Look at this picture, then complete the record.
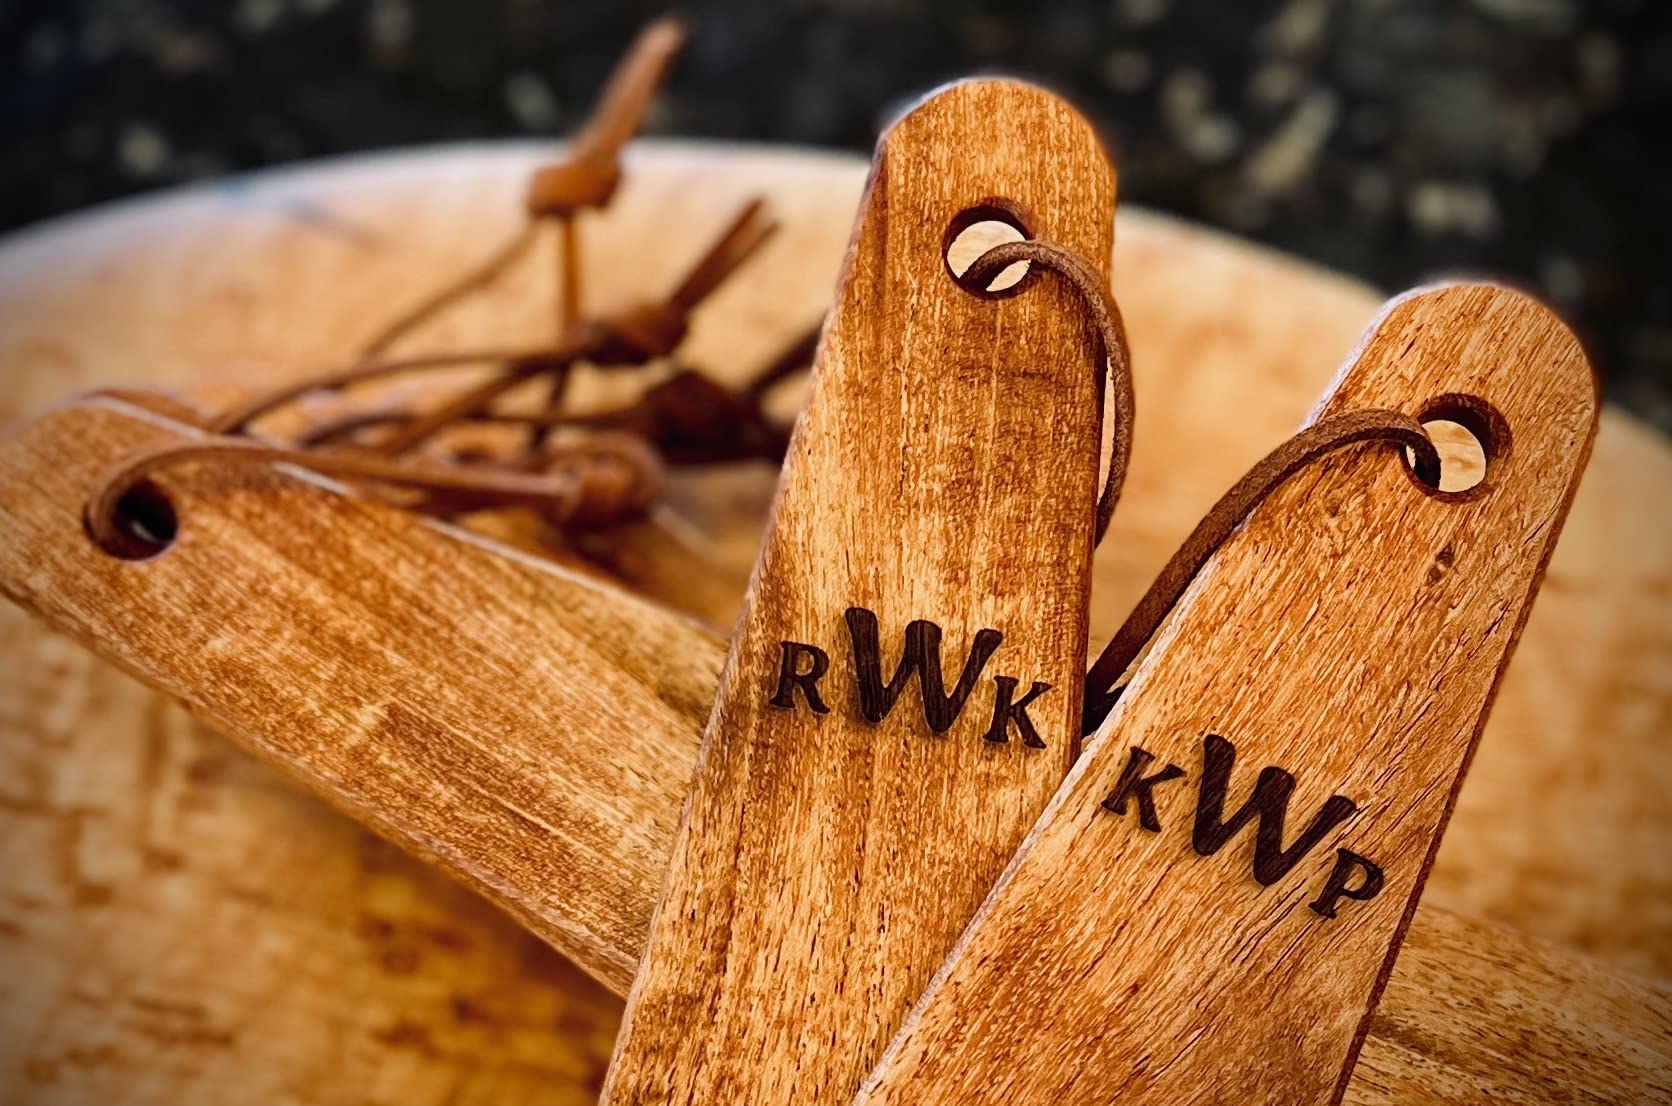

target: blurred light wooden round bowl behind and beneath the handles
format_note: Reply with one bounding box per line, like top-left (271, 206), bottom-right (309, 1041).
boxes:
top-left (0, 146), bottom-right (1672, 1104)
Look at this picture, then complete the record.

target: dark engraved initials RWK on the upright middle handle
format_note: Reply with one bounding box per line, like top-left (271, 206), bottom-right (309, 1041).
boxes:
top-left (767, 607), bottom-right (1050, 750)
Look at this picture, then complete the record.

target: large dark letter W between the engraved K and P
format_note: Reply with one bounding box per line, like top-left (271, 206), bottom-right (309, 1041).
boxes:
top-left (1190, 733), bottom-right (1358, 887)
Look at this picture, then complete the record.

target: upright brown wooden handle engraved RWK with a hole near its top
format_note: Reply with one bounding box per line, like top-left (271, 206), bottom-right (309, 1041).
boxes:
top-left (604, 80), bottom-right (1115, 1106)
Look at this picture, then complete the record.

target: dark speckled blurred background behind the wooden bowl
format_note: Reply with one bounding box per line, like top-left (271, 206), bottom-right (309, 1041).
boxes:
top-left (0, 0), bottom-right (1672, 430)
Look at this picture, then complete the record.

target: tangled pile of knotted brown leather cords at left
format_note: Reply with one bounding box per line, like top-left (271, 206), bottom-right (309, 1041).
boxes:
top-left (84, 17), bottom-right (794, 556)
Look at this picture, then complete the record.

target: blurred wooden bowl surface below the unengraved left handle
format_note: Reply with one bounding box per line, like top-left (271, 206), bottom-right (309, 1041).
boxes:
top-left (0, 604), bottom-right (620, 1106)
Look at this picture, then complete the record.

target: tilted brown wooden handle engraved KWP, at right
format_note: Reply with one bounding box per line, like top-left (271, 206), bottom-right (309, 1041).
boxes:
top-left (856, 284), bottom-right (1597, 1106)
